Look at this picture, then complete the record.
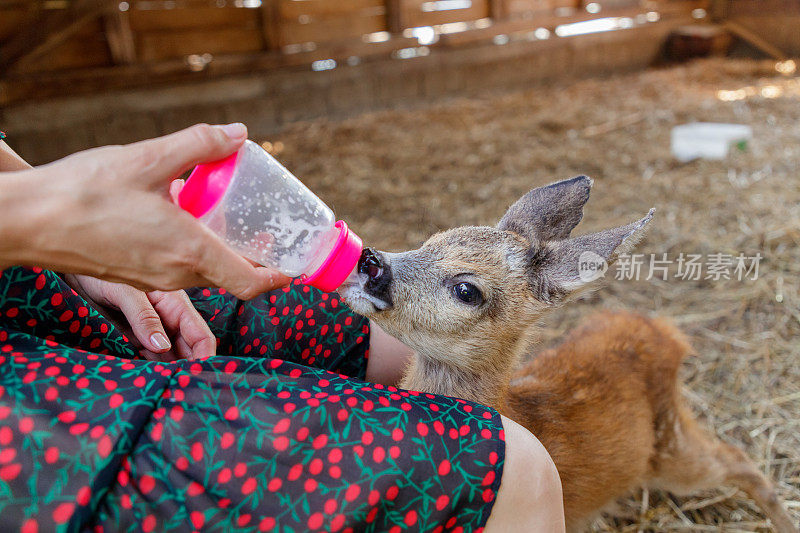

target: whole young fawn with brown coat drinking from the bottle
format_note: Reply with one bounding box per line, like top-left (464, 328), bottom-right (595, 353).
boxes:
top-left (340, 176), bottom-right (797, 533)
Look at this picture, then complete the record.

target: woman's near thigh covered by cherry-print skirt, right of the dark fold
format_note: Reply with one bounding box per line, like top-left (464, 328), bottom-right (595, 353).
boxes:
top-left (96, 357), bottom-right (504, 531)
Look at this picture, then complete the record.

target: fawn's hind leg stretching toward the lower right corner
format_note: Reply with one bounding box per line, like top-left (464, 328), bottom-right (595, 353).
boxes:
top-left (654, 406), bottom-right (798, 533)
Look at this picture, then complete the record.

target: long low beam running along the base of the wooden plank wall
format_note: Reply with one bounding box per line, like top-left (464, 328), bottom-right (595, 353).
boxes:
top-left (0, 15), bottom-right (692, 164)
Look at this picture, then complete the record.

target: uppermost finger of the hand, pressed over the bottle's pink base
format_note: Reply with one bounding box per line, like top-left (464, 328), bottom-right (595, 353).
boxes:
top-left (130, 122), bottom-right (247, 186)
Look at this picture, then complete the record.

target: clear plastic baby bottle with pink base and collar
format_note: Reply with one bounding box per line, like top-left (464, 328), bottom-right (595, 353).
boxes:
top-left (178, 140), bottom-right (362, 292)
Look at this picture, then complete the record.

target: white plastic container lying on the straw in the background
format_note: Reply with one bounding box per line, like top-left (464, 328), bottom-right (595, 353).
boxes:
top-left (671, 122), bottom-right (753, 162)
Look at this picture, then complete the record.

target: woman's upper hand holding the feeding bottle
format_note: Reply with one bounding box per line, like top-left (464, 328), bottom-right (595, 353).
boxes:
top-left (0, 124), bottom-right (289, 299)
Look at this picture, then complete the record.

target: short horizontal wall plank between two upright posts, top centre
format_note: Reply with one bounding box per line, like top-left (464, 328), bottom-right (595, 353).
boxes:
top-left (280, 14), bottom-right (387, 46)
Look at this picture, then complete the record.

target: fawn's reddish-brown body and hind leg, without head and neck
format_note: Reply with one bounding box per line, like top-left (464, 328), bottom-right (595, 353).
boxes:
top-left (504, 312), bottom-right (796, 533)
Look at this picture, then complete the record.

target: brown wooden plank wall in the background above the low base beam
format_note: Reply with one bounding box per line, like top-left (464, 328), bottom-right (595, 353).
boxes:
top-left (0, 0), bottom-right (692, 105)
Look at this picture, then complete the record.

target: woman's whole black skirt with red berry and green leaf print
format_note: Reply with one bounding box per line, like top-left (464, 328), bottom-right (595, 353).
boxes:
top-left (0, 267), bottom-right (505, 533)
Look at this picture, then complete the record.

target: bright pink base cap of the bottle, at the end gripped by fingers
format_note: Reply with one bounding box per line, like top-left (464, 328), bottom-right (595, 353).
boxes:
top-left (178, 152), bottom-right (239, 218)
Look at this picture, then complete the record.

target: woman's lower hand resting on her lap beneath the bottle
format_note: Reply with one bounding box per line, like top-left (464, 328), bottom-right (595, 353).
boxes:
top-left (65, 274), bottom-right (217, 361)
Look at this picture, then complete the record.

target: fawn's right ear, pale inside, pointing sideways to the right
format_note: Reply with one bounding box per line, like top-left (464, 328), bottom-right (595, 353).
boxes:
top-left (527, 209), bottom-right (655, 304)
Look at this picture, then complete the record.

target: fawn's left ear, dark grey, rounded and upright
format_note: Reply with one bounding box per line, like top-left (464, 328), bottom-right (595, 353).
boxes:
top-left (497, 176), bottom-right (592, 242)
